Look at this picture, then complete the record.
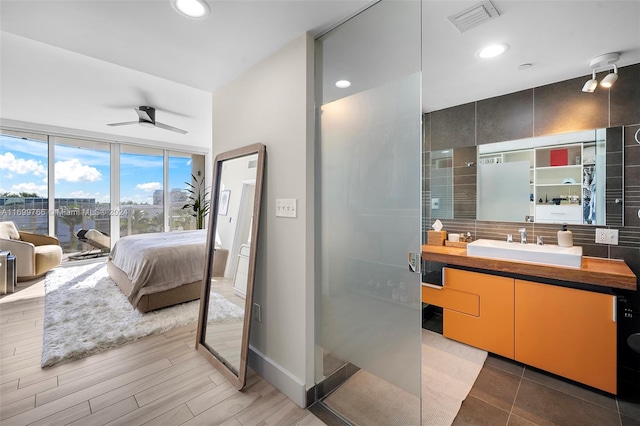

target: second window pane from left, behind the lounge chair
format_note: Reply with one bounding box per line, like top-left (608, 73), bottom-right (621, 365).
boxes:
top-left (54, 138), bottom-right (111, 253)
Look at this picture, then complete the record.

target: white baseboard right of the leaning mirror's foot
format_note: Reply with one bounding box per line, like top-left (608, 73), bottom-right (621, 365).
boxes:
top-left (249, 345), bottom-right (307, 408)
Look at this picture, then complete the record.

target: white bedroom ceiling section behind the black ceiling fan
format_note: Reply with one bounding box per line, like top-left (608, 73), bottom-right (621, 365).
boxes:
top-left (0, 31), bottom-right (212, 156)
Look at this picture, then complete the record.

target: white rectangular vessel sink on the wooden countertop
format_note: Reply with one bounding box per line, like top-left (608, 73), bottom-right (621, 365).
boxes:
top-left (467, 239), bottom-right (582, 268)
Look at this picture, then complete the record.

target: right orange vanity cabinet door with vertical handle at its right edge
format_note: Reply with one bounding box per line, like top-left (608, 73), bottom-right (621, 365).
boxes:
top-left (515, 279), bottom-right (617, 394)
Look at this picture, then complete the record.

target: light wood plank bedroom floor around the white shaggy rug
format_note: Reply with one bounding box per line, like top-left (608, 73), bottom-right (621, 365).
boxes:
top-left (0, 280), bottom-right (324, 426)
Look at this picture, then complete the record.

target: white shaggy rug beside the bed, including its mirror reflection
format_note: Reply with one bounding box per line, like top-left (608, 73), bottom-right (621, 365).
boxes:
top-left (41, 262), bottom-right (243, 367)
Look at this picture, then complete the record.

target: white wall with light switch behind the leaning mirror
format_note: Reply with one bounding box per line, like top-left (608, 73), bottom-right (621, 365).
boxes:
top-left (213, 34), bottom-right (314, 406)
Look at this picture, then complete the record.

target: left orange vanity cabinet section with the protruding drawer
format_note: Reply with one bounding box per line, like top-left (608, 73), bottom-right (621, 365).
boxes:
top-left (422, 268), bottom-right (514, 358)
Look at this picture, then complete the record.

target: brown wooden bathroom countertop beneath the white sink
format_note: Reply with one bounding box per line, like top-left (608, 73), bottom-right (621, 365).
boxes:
top-left (422, 244), bottom-right (637, 290)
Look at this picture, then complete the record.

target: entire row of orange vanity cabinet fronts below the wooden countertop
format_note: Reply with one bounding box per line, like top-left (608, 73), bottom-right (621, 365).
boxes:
top-left (422, 267), bottom-right (617, 394)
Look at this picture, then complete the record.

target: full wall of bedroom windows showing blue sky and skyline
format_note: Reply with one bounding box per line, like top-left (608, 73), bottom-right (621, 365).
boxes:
top-left (0, 129), bottom-right (205, 253)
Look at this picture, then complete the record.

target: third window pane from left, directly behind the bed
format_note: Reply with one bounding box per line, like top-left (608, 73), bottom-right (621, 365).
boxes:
top-left (120, 145), bottom-right (164, 237)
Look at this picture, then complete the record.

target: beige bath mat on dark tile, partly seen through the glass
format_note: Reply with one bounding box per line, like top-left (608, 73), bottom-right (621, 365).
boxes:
top-left (325, 330), bottom-right (487, 426)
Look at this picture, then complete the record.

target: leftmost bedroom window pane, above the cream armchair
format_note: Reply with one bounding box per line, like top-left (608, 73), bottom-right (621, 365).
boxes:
top-left (0, 131), bottom-right (49, 234)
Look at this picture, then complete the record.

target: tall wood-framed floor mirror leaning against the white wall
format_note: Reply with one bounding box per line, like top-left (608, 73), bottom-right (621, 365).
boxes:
top-left (196, 144), bottom-right (266, 389)
